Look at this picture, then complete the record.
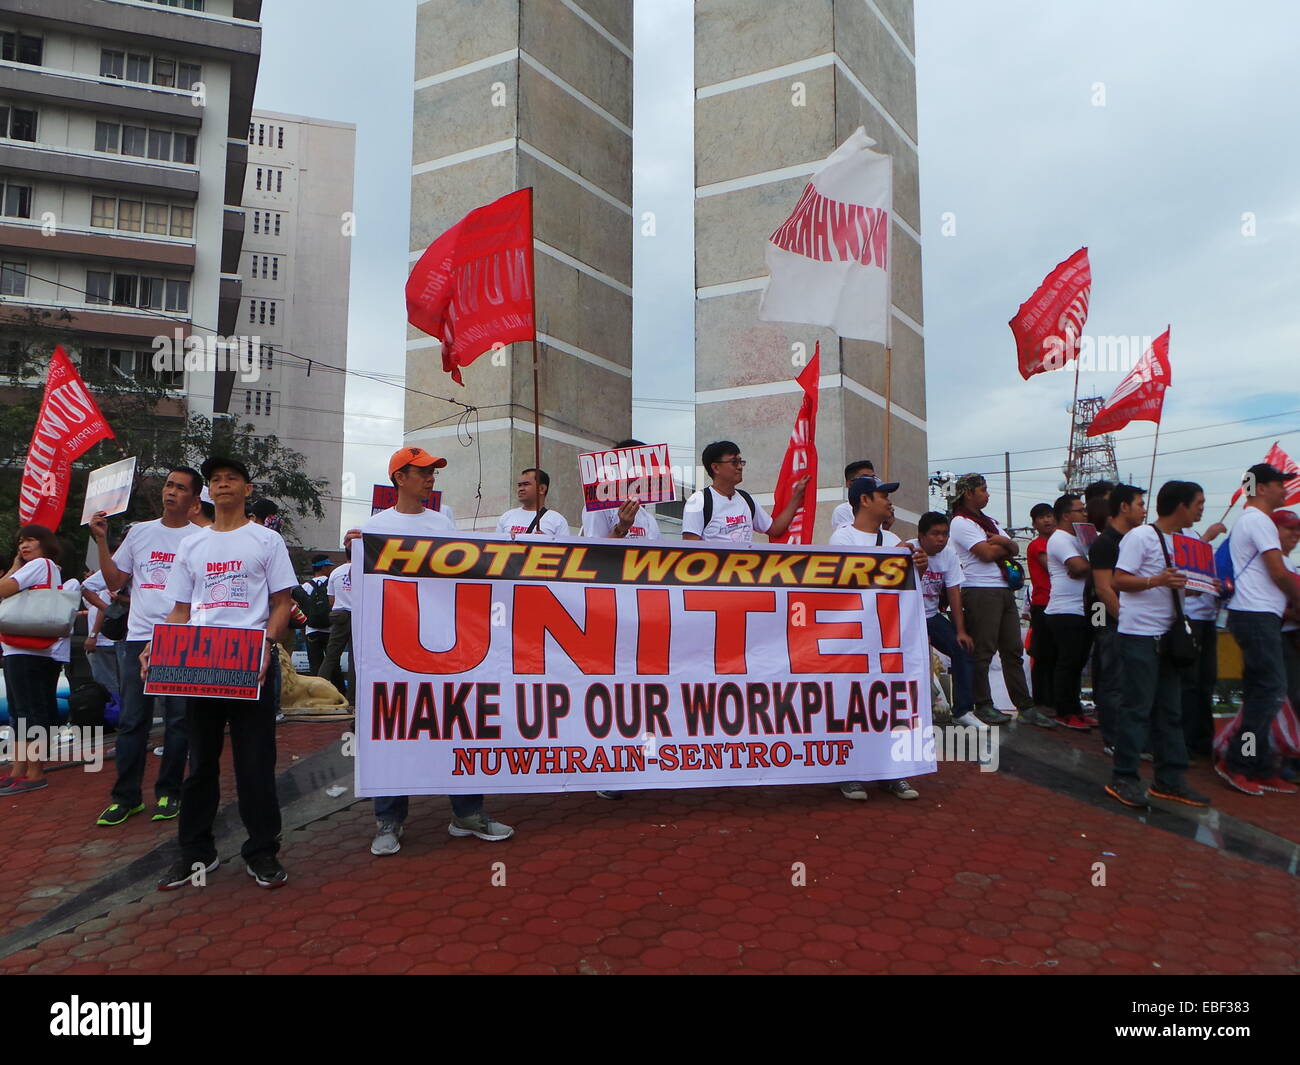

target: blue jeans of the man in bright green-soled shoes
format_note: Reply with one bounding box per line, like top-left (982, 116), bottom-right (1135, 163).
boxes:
top-left (111, 640), bottom-right (190, 809)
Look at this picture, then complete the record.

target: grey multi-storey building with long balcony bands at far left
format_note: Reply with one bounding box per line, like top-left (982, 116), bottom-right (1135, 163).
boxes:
top-left (0, 0), bottom-right (261, 414)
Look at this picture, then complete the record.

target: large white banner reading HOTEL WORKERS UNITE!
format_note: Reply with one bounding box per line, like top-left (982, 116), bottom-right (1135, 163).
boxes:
top-left (352, 533), bottom-right (935, 796)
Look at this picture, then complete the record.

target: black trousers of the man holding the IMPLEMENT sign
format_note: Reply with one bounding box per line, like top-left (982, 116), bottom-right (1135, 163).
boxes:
top-left (178, 649), bottom-right (280, 863)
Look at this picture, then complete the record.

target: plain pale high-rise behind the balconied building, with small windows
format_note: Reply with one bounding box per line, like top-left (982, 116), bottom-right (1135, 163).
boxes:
top-left (239, 111), bottom-right (356, 550)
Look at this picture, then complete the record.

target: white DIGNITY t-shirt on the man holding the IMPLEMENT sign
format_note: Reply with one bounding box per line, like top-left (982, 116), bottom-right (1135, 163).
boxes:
top-left (166, 521), bottom-right (298, 628)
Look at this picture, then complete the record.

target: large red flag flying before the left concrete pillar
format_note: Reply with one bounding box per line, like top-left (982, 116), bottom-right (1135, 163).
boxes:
top-left (406, 189), bottom-right (537, 385)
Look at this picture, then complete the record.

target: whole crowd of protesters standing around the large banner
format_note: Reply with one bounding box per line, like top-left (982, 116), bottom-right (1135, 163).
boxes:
top-left (0, 440), bottom-right (1300, 889)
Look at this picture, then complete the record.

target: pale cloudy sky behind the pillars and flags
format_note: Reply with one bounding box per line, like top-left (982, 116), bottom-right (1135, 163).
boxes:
top-left (256, 0), bottom-right (1300, 538)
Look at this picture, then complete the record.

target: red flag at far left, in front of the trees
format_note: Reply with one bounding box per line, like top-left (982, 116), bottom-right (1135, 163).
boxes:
top-left (18, 347), bottom-right (113, 531)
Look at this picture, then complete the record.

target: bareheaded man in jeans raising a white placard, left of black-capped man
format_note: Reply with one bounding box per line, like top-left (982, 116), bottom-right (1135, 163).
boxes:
top-left (90, 466), bottom-right (203, 828)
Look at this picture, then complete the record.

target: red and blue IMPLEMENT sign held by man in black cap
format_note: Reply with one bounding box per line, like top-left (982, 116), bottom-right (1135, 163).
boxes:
top-left (144, 624), bottom-right (267, 700)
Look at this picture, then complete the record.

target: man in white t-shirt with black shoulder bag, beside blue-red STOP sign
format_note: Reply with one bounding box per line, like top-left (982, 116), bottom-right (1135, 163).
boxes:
top-left (1106, 481), bottom-right (1210, 808)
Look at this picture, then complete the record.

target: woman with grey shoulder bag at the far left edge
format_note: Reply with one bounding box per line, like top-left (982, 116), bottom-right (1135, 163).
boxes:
top-left (0, 525), bottom-right (69, 796)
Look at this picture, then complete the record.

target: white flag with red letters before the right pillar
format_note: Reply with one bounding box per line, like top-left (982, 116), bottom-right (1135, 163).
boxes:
top-left (758, 126), bottom-right (893, 343)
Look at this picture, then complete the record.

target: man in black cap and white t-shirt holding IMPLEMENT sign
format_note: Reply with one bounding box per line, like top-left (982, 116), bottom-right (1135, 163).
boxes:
top-left (150, 458), bottom-right (298, 891)
